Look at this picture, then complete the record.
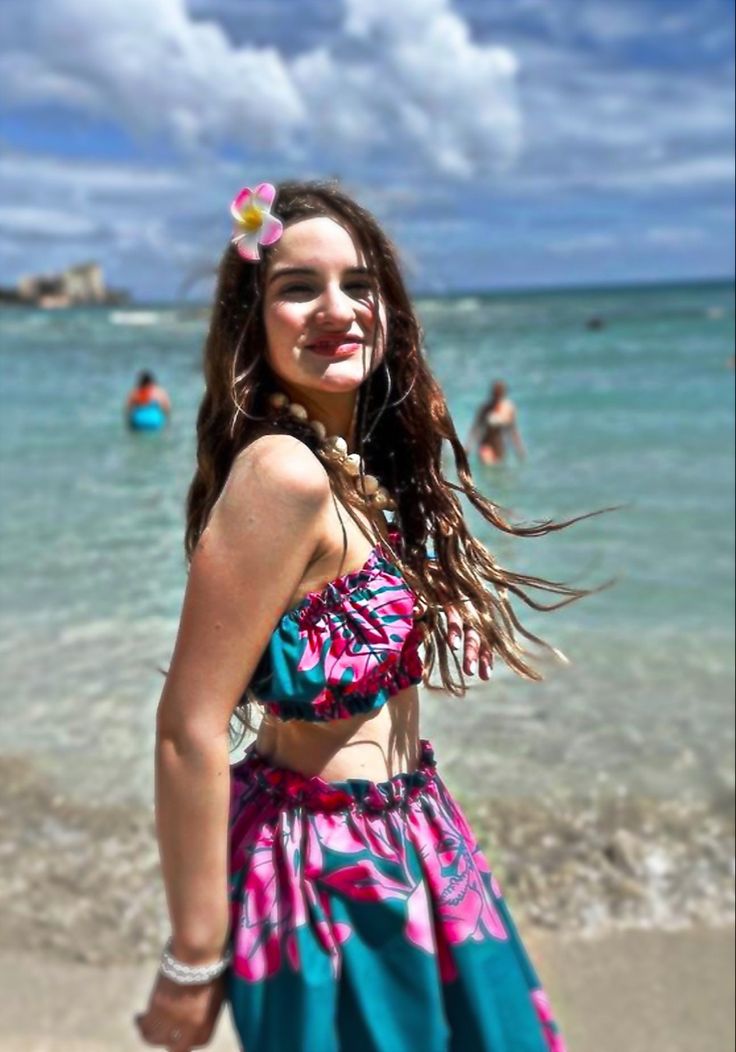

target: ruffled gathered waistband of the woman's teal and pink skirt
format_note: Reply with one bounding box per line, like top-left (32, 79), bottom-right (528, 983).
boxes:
top-left (232, 739), bottom-right (437, 812)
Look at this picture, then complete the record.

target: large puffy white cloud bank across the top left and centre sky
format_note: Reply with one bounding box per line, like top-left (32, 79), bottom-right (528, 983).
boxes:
top-left (0, 0), bottom-right (520, 176)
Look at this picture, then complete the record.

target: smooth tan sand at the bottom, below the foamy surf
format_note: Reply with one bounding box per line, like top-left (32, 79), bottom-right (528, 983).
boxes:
top-left (0, 928), bottom-right (734, 1052)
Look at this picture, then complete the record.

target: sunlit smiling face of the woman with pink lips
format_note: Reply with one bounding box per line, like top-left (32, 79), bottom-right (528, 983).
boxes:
top-left (263, 216), bottom-right (386, 404)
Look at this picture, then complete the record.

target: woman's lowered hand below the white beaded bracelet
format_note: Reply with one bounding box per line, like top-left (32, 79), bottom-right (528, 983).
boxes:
top-left (135, 974), bottom-right (225, 1052)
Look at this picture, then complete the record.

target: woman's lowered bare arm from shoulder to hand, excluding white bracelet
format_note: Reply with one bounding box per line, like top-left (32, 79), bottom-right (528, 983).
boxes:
top-left (139, 436), bottom-right (331, 1044)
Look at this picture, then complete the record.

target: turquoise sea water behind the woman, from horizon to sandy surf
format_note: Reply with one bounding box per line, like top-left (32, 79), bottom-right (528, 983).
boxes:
top-left (0, 285), bottom-right (734, 801)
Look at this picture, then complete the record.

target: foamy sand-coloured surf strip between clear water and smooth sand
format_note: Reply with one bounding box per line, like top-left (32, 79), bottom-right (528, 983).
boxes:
top-left (0, 757), bottom-right (734, 968)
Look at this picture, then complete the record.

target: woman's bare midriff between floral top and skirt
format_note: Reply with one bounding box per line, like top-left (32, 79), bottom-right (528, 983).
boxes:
top-left (255, 687), bottom-right (420, 782)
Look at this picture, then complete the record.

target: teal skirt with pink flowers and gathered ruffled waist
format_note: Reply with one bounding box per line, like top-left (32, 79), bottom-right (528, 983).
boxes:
top-left (228, 741), bottom-right (565, 1052)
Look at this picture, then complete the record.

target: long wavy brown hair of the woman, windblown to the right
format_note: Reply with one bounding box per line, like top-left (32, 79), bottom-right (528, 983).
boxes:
top-left (185, 182), bottom-right (600, 726)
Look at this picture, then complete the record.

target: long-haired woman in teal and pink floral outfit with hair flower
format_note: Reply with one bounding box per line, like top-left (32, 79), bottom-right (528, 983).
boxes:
top-left (132, 182), bottom-right (597, 1052)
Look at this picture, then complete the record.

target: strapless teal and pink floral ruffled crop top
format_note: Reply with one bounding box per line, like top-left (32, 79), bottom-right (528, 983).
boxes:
top-left (248, 532), bottom-right (423, 722)
